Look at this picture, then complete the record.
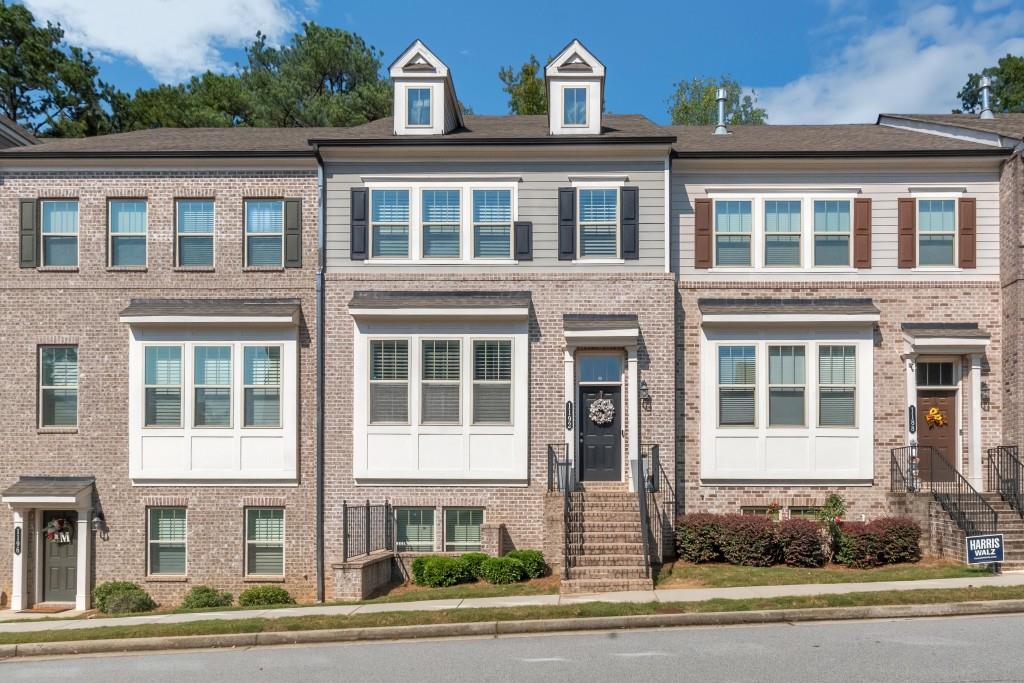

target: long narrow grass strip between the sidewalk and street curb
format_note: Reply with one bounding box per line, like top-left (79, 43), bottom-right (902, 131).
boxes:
top-left (0, 586), bottom-right (1024, 644)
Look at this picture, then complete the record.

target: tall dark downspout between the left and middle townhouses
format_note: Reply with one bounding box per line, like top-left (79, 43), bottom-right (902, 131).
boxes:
top-left (313, 145), bottom-right (327, 602)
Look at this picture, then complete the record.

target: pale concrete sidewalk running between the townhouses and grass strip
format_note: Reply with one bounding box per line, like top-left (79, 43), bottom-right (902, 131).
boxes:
top-left (0, 572), bottom-right (1024, 633)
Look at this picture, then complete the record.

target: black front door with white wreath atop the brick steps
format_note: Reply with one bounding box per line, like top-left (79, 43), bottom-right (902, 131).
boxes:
top-left (579, 386), bottom-right (623, 481)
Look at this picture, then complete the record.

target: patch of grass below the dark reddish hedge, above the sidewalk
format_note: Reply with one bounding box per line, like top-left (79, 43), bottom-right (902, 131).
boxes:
top-left (657, 560), bottom-right (988, 588)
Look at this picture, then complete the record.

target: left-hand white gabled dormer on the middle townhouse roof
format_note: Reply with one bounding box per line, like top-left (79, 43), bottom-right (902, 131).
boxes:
top-left (388, 40), bottom-right (462, 135)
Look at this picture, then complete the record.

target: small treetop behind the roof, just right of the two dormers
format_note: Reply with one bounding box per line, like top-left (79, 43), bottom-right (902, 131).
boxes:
top-left (669, 76), bottom-right (768, 126)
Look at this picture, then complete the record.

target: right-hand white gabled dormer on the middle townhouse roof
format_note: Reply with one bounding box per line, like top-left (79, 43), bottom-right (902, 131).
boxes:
top-left (544, 39), bottom-right (604, 135)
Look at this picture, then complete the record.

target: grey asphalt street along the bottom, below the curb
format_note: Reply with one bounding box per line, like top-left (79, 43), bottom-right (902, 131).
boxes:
top-left (0, 615), bottom-right (1024, 683)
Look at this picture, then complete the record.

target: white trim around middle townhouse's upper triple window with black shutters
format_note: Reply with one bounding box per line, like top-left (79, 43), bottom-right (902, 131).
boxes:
top-left (361, 177), bottom-right (519, 266)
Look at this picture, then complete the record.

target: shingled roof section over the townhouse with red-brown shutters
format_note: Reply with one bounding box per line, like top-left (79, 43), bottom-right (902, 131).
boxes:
top-left (667, 124), bottom-right (1007, 158)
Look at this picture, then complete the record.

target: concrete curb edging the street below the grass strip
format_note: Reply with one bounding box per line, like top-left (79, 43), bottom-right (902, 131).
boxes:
top-left (6, 600), bottom-right (1024, 659)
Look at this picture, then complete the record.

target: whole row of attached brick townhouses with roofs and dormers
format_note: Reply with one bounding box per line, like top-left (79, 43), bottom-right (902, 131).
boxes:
top-left (0, 41), bottom-right (1024, 609)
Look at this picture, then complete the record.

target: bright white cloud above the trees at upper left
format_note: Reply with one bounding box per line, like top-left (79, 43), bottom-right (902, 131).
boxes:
top-left (25, 0), bottom-right (297, 83)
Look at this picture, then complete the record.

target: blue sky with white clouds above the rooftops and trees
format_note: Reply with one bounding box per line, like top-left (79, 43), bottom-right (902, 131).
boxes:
top-left (24, 0), bottom-right (1024, 123)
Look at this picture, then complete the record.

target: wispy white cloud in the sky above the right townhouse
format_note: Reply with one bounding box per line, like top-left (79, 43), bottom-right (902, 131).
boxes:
top-left (755, 5), bottom-right (1024, 124)
